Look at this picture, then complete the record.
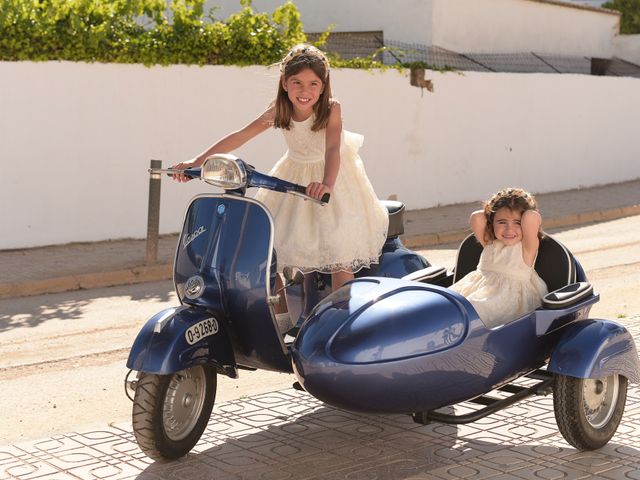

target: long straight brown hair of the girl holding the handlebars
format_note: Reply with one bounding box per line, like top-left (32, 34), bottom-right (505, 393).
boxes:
top-left (273, 44), bottom-right (331, 132)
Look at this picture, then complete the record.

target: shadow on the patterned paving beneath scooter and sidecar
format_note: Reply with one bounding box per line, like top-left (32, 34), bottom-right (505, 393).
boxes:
top-left (136, 400), bottom-right (640, 480)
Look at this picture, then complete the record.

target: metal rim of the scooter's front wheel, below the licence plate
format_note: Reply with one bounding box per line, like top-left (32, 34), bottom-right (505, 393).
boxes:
top-left (162, 366), bottom-right (207, 441)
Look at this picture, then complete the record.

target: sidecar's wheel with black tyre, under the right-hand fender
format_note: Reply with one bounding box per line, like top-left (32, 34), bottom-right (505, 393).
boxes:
top-left (553, 374), bottom-right (627, 450)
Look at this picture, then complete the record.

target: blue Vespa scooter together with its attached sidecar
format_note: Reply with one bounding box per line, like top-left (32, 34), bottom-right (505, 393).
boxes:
top-left (127, 155), bottom-right (640, 459)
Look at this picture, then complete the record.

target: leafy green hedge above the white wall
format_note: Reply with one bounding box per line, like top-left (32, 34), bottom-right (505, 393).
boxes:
top-left (0, 0), bottom-right (306, 65)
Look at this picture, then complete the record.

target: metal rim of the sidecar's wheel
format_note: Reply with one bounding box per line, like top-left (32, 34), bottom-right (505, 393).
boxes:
top-left (582, 375), bottom-right (620, 429)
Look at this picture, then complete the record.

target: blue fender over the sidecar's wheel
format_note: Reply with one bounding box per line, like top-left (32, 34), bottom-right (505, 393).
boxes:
top-left (547, 320), bottom-right (640, 383)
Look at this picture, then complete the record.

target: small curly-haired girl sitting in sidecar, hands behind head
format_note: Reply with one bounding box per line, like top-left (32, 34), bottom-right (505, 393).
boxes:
top-left (451, 188), bottom-right (547, 328)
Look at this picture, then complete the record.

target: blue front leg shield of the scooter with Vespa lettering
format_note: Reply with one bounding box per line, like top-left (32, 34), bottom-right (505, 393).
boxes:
top-left (174, 195), bottom-right (291, 372)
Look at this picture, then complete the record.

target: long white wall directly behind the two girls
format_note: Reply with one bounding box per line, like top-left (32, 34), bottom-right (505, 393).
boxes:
top-left (0, 62), bottom-right (640, 249)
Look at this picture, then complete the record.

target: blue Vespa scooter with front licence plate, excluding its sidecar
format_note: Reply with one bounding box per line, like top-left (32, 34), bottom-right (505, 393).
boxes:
top-left (126, 154), bottom-right (436, 459)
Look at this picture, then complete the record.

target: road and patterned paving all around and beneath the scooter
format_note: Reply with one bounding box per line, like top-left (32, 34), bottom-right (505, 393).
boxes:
top-left (0, 216), bottom-right (640, 479)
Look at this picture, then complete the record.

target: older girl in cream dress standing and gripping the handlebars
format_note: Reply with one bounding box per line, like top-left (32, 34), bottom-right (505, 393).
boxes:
top-left (172, 45), bottom-right (388, 289)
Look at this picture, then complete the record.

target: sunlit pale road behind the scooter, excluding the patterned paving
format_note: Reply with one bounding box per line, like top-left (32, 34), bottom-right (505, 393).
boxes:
top-left (0, 216), bottom-right (640, 443)
